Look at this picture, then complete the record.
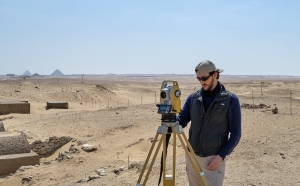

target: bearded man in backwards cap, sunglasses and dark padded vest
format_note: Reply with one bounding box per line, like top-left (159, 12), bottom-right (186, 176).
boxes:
top-left (177, 60), bottom-right (241, 186)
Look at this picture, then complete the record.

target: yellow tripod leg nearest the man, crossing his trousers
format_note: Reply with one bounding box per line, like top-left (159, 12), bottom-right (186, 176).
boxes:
top-left (177, 132), bottom-right (210, 186)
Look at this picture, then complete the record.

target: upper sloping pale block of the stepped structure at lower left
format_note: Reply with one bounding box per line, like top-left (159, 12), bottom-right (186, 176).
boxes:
top-left (0, 135), bottom-right (31, 155)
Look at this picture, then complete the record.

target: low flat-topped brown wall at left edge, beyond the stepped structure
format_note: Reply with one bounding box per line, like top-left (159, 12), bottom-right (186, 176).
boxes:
top-left (0, 102), bottom-right (30, 115)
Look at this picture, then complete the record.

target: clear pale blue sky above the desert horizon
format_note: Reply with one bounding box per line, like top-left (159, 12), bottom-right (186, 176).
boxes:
top-left (0, 0), bottom-right (300, 76)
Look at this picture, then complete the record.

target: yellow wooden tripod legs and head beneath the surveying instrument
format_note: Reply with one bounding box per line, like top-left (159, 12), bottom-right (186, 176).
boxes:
top-left (136, 120), bottom-right (210, 186)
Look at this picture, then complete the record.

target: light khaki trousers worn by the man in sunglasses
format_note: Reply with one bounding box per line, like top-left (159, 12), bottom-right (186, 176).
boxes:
top-left (185, 155), bottom-right (225, 186)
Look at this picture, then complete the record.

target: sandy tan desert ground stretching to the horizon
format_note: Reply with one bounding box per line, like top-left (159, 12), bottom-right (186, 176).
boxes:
top-left (0, 74), bottom-right (300, 186)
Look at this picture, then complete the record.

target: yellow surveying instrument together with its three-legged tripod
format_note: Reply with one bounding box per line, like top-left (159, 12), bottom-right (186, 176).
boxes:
top-left (136, 80), bottom-right (210, 186)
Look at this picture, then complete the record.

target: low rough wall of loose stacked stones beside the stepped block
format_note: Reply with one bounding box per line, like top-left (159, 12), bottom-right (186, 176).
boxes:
top-left (29, 136), bottom-right (72, 155)
